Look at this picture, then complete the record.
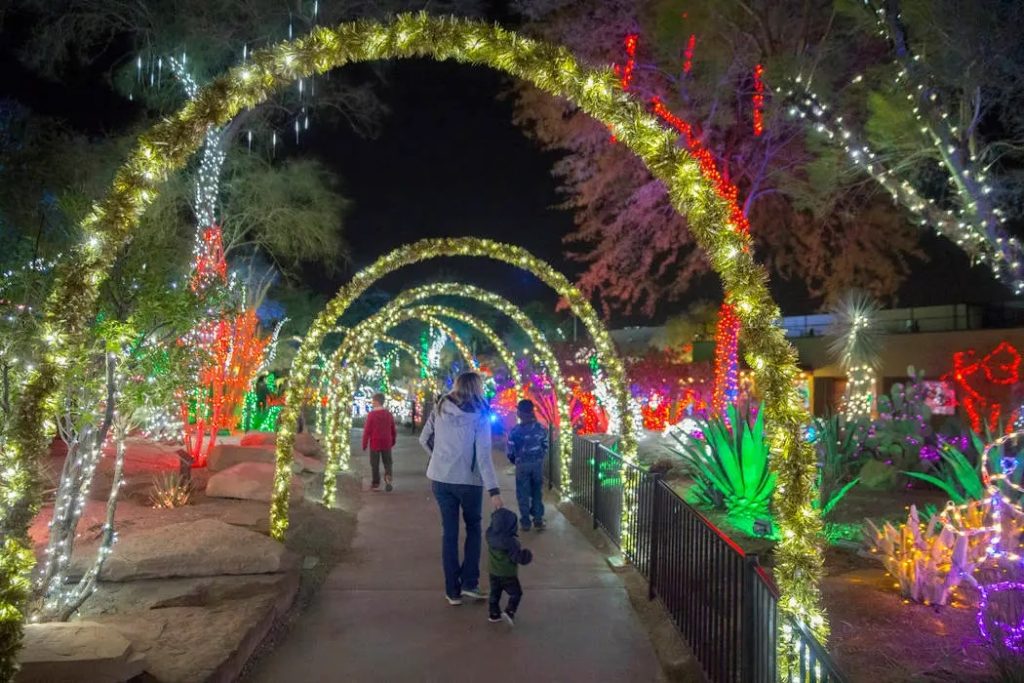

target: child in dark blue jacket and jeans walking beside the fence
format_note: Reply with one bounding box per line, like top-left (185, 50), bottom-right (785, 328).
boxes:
top-left (508, 399), bottom-right (548, 531)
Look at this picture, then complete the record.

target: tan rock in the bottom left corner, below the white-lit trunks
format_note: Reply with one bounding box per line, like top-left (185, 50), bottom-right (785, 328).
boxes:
top-left (14, 622), bottom-right (145, 683)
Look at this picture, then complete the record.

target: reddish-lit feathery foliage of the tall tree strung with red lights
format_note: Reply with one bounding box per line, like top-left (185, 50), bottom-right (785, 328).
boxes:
top-left (517, 0), bottom-right (918, 313)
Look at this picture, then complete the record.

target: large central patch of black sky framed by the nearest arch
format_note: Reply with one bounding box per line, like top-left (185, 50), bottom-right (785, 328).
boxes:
top-left (302, 59), bottom-right (578, 311)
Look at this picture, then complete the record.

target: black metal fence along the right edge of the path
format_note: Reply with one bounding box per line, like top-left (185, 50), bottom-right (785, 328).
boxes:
top-left (561, 436), bottom-right (845, 683)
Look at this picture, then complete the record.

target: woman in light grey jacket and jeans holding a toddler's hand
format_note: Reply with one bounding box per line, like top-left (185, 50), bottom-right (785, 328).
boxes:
top-left (420, 373), bottom-right (502, 605)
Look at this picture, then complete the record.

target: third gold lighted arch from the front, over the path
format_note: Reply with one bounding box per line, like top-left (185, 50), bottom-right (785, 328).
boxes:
top-left (307, 283), bottom-right (572, 505)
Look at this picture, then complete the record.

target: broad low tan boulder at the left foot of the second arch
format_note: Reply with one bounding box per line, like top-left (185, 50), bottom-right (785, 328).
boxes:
top-left (100, 519), bottom-right (294, 581)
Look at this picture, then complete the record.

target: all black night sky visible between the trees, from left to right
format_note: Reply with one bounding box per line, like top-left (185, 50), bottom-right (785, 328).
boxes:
top-left (0, 16), bottom-right (1008, 325)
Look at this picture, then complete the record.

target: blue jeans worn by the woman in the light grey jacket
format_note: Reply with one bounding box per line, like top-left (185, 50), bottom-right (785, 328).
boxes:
top-left (430, 481), bottom-right (483, 598)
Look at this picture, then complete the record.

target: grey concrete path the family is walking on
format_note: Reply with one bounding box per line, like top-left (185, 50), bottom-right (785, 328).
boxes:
top-left (252, 436), bottom-right (659, 683)
